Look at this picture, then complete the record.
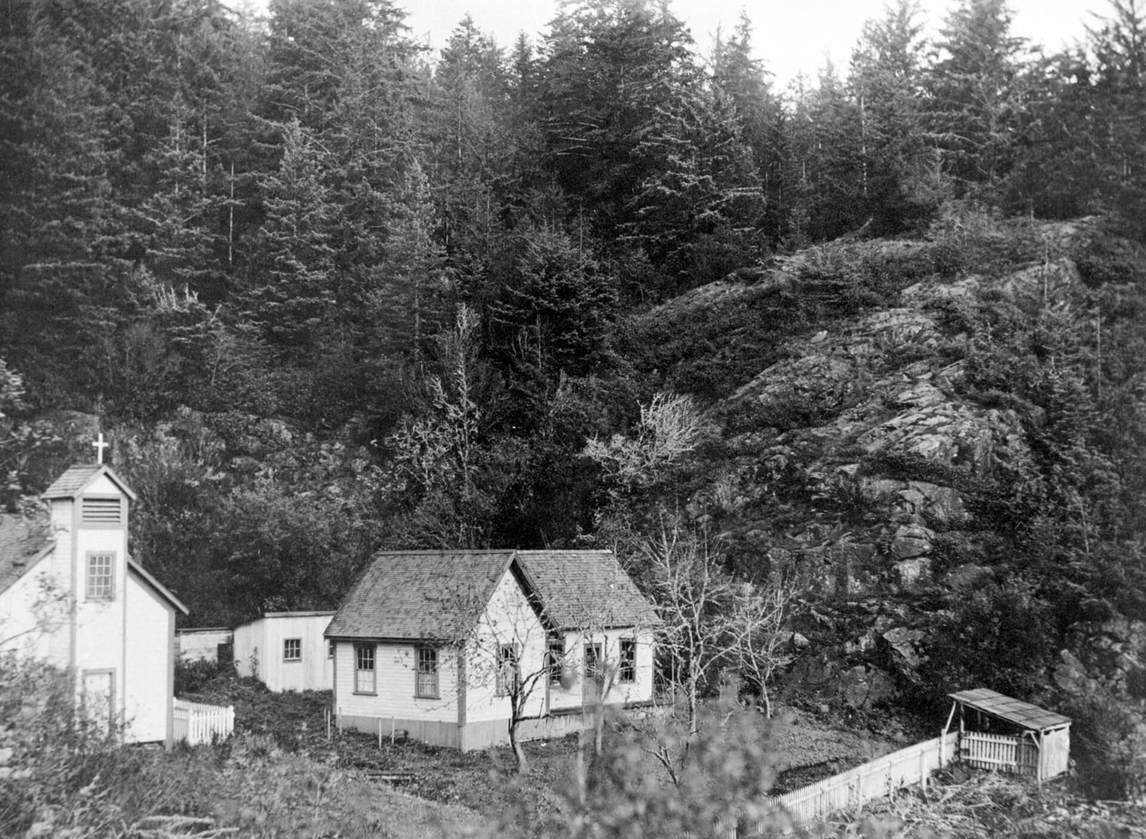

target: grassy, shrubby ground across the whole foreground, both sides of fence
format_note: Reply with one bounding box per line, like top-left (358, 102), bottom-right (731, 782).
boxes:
top-left (8, 660), bottom-right (1146, 839)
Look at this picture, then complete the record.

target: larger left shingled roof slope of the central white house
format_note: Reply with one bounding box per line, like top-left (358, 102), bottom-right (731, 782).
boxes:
top-left (325, 550), bottom-right (513, 641)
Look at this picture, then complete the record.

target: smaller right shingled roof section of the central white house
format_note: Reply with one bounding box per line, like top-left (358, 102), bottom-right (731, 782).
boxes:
top-left (516, 550), bottom-right (661, 629)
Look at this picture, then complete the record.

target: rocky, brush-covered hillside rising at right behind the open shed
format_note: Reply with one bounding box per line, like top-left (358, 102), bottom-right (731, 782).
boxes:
top-left (631, 213), bottom-right (1146, 793)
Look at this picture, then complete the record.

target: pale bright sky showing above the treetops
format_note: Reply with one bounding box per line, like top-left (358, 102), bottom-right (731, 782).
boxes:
top-left (398, 0), bottom-right (1109, 85)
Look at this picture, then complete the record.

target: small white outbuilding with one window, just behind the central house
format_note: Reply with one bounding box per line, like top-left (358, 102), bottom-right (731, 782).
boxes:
top-left (234, 612), bottom-right (335, 691)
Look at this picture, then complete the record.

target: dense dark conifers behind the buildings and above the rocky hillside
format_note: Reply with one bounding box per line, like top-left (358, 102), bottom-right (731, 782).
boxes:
top-left (0, 0), bottom-right (1146, 641)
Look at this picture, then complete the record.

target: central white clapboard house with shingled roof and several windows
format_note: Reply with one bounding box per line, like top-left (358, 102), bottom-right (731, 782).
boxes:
top-left (327, 550), bottom-right (659, 750)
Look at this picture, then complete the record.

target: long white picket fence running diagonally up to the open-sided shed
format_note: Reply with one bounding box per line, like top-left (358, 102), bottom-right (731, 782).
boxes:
top-left (774, 731), bottom-right (959, 824)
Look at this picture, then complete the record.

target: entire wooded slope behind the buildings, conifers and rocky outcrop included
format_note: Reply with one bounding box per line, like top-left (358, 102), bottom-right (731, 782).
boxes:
top-left (0, 0), bottom-right (1146, 798)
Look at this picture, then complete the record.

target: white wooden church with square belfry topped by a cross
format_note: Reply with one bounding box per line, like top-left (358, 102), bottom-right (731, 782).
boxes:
top-left (0, 458), bottom-right (187, 744)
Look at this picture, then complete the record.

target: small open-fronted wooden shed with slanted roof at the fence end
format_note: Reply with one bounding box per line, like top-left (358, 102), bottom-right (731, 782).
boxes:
top-left (943, 688), bottom-right (1070, 781)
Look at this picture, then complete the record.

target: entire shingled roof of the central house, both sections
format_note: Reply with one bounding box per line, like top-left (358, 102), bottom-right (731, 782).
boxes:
top-left (325, 550), bottom-right (659, 641)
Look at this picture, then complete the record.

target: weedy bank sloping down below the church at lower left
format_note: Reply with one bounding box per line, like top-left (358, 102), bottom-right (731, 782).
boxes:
top-left (0, 658), bottom-right (476, 839)
